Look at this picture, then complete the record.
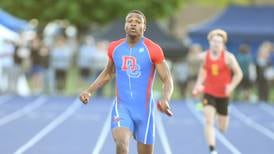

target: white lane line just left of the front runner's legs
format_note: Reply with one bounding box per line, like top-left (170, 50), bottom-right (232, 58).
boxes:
top-left (92, 101), bottom-right (113, 154)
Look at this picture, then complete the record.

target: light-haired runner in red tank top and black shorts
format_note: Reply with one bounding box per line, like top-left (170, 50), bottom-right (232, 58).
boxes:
top-left (193, 29), bottom-right (243, 154)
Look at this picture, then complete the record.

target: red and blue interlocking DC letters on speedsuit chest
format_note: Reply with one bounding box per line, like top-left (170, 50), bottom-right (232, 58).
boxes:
top-left (122, 56), bottom-right (141, 78)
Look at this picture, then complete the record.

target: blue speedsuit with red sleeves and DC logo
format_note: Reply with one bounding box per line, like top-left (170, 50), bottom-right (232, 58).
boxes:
top-left (108, 37), bottom-right (164, 144)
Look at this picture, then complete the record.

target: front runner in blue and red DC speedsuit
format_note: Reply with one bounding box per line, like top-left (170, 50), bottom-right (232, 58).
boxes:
top-left (80, 10), bottom-right (173, 154)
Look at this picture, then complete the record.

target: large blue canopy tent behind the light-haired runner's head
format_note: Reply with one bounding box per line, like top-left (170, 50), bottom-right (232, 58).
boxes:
top-left (188, 6), bottom-right (274, 56)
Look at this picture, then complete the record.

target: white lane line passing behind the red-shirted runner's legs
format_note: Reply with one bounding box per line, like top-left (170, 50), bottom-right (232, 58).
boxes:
top-left (186, 101), bottom-right (241, 154)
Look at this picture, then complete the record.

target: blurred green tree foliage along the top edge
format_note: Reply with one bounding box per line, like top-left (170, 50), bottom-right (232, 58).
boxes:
top-left (0, 0), bottom-right (184, 27)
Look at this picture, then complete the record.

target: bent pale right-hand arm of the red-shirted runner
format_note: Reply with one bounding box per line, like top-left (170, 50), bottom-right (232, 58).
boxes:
top-left (226, 53), bottom-right (243, 96)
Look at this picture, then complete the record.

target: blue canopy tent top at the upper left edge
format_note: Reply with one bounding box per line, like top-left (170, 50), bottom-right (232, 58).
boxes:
top-left (0, 9), bottom-right (28, 32)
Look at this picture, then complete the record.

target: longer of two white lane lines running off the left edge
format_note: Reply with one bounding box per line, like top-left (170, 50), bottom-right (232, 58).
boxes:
top-left (0, 96), bottom-right (46, 126)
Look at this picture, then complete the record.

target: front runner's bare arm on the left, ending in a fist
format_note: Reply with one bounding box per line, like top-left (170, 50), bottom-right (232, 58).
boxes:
top-left (80, 60), bottom-right (115, 104)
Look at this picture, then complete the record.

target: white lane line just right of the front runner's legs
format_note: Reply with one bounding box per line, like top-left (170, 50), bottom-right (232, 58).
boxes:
top-left (156, 114), bottom-right (172, 154)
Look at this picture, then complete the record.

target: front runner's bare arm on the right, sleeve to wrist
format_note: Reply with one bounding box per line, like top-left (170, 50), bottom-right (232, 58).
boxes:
top-left (156, 60), bottom-right (173, 108)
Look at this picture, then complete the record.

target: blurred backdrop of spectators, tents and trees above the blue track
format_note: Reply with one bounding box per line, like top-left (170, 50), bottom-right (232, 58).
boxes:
top-left (0, 0), bottom-right (274, 102)
